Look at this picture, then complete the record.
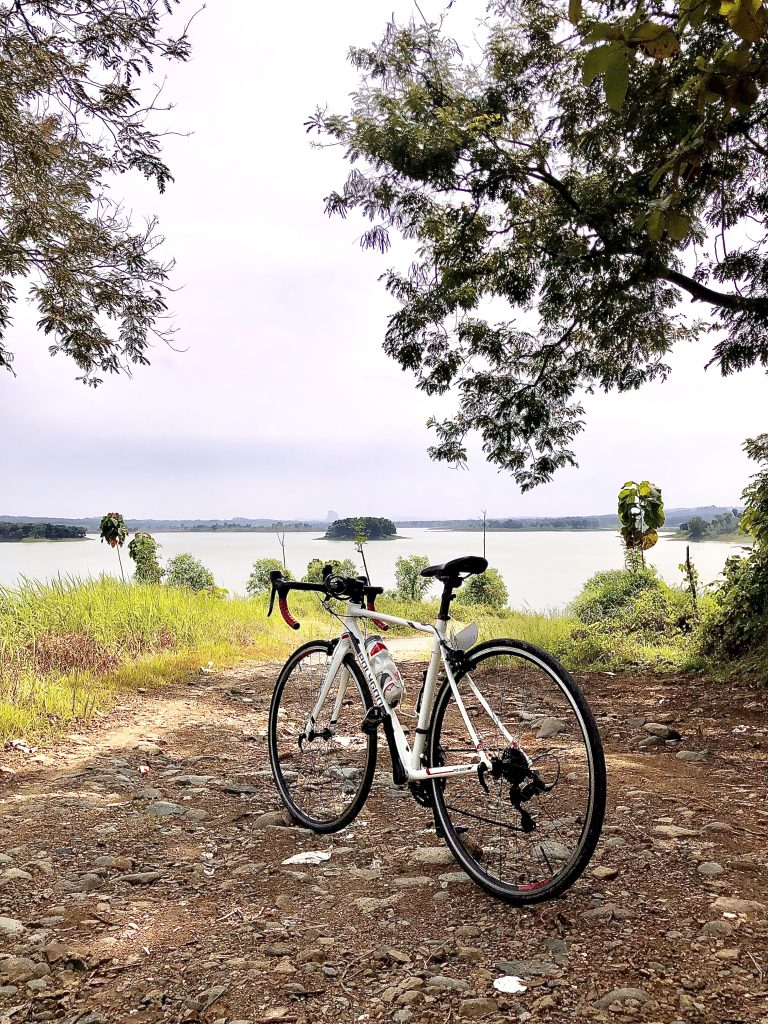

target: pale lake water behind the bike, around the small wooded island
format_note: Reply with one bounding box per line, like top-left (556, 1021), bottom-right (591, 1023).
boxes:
top-left (0, 527), bottom-right (741, 610)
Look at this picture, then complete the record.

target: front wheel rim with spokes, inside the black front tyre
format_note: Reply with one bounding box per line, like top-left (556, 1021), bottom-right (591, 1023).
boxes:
top-left (270, 646), bottom-right (370, 824)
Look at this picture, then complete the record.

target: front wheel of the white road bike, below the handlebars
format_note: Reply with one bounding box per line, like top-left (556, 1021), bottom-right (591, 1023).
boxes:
top-left (267, 640), bottom-right (376, 833)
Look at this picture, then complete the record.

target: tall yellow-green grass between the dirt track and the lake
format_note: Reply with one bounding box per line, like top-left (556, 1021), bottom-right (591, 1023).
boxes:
top-left (0, 577), bottom-right (692, 738)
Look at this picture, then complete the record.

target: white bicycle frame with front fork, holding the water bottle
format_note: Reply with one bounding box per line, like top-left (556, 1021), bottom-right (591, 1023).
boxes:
top-left (304, 603), bottom-right (518, 784)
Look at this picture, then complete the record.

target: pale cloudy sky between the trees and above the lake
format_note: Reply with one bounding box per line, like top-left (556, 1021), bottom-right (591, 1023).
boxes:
top-left (0, 0), bottom-right (766, 517)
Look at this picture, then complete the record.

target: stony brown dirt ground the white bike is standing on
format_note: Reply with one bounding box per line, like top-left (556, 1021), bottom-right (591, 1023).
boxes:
top-left (0, 664), bottom-right (768, 1024)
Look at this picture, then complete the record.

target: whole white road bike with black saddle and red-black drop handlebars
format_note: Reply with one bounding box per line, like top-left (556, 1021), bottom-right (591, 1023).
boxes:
top-left (268, 556), bottom-right (605, 905)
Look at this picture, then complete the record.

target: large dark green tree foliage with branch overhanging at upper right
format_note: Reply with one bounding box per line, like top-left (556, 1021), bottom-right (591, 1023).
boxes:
top-left (308, 8), bottom-right (768, 489)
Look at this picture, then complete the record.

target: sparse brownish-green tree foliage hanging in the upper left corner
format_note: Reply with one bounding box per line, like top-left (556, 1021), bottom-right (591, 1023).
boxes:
top-left (0, 0), bottom-right (189, 384)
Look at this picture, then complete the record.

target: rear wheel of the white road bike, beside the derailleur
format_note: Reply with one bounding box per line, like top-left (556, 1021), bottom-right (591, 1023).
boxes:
top-left (429, 640), bottom-right (605, 905)
